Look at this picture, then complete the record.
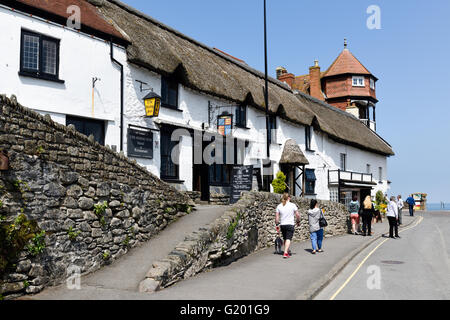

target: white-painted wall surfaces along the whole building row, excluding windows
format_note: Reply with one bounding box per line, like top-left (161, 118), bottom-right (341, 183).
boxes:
top-left (0, 7), bottom-right (388, 199)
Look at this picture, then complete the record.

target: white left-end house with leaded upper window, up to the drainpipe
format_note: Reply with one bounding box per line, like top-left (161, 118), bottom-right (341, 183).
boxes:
top-left (0, 1), bottom-right (126, 147)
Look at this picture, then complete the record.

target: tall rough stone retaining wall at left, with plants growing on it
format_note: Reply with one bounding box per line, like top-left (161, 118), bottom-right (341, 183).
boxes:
top-left (0, 96), bottom-right (193, 298)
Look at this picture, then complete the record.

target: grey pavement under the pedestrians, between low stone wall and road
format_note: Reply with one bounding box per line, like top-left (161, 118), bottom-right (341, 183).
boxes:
top-left (145, 217), bottom-right (413, 300)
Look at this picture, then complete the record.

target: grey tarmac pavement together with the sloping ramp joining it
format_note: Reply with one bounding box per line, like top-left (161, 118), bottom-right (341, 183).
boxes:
top-left (24, 206), bottom-right (416, 300)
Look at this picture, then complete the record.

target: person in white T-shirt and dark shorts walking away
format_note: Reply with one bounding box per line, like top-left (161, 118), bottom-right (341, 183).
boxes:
top-left (275, 193), bottom-right (300, 259)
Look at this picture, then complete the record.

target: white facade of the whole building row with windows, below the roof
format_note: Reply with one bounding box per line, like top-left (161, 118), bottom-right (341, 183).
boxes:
top-left (0, 1), bottom-right (393, 203)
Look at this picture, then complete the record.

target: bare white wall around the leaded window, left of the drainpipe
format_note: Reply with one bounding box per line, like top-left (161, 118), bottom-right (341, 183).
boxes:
top-left (0, 7), bottom-right (126, 148)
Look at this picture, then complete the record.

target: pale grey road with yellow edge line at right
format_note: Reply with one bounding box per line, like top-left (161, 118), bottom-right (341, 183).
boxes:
top-left (316, 212), bottom-right (450, 300)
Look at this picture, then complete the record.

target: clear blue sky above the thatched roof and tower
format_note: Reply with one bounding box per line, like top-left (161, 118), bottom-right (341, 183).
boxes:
top-left (125, 0), bottom-right (450, 202)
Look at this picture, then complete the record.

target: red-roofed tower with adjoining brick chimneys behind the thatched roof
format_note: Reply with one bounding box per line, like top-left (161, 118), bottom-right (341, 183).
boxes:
top-left (277, 39), bottom-right (378, 130)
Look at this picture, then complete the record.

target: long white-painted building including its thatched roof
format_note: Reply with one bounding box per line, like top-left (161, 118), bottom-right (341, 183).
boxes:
top-left (0, 0), bottom-right (393, 202)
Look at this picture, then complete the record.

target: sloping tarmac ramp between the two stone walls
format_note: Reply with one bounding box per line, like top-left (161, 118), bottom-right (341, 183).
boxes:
top-left (30, 205), bottom-right (226, 300)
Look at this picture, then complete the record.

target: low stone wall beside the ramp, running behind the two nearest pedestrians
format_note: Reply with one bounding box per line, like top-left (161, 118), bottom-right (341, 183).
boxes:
top-left (140, 192), bottom-right (349, 292)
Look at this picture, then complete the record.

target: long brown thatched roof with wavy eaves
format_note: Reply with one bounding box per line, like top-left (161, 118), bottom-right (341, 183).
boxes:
top-left (94, 0), bottom-right (393, 155)
